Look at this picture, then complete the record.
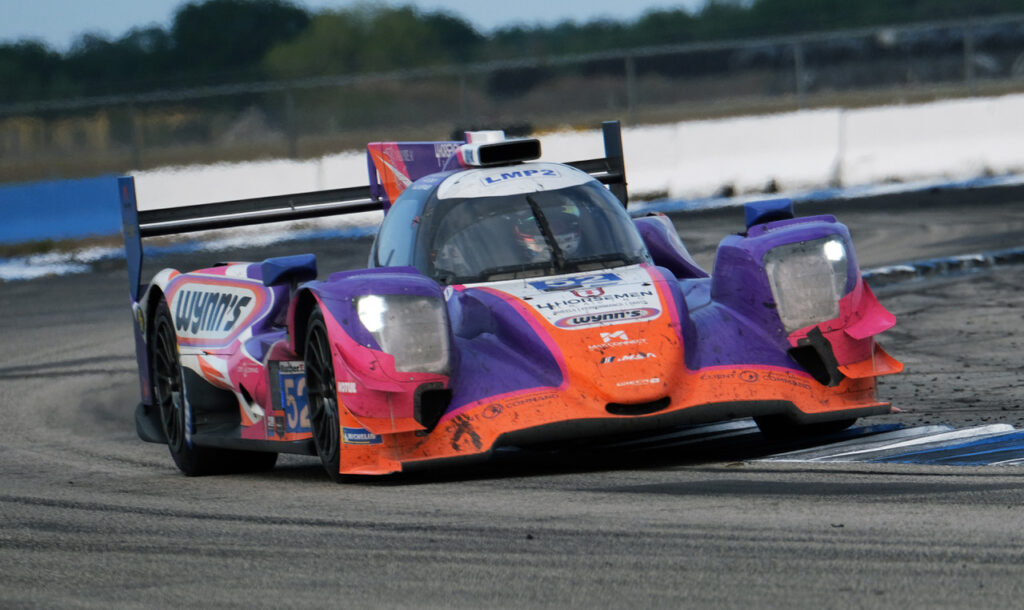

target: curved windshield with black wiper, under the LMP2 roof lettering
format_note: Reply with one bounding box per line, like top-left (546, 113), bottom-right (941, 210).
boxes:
top-left (421, 182), bottom-right (648, 284)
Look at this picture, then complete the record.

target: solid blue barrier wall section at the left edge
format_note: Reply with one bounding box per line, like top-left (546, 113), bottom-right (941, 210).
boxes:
top-left (0, 175), bottom-right (121, 244)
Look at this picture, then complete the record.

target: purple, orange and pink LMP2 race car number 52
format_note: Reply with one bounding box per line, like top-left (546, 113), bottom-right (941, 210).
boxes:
top-left (119, 122), bottom-right (902, 480)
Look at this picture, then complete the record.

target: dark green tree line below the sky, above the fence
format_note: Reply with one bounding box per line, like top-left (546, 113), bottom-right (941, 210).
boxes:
top-left (0, 0), bottom-right (1024, 103)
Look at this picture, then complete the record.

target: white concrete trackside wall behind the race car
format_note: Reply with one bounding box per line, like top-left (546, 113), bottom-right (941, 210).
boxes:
top-left (135, 94), bottom-right (1024, 209)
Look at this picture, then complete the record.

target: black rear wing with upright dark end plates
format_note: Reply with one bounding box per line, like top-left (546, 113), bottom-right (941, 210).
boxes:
top-left (118, 121), bottom-right (629, 301)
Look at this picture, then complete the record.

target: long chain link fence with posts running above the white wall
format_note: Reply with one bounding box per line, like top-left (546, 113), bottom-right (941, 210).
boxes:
top-left (0, 15), bottom-right (1024, 182)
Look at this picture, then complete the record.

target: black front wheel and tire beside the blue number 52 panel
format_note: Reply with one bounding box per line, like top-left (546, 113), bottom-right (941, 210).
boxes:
top-left (303, 307), bottom-right (348, 483)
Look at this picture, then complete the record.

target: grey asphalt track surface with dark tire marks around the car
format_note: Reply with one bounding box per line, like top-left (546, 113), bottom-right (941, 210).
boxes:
top-left (0, 186), bottom-right (1024, 608)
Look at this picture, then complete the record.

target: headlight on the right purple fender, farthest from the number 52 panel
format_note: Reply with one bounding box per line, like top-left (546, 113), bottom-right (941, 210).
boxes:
top-left (764, 236), bottom-right (847, 333)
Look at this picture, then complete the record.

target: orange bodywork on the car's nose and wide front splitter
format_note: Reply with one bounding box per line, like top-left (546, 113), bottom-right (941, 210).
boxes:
top-left (327, 270), bottom-right (902, 474)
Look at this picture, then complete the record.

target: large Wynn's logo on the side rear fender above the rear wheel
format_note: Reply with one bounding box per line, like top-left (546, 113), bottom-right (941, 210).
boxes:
top-left (171, 284), bottom-right (256, 339)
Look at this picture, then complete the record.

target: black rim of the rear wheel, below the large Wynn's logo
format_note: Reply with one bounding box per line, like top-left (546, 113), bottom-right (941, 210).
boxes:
top-left (153, 316), bottom-right (185, 451)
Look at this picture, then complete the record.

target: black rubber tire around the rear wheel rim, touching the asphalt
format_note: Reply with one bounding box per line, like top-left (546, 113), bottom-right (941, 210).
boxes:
top-left (150, 300), bottom-right (278, 477)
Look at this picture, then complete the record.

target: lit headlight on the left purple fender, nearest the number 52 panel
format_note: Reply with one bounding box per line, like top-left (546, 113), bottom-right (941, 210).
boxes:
top-left (355, 295), bottom-right (450, 375)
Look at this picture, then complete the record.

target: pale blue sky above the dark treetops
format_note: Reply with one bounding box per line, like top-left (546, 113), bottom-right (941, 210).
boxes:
top-left (0, 0), bottom-right (705, 52)
